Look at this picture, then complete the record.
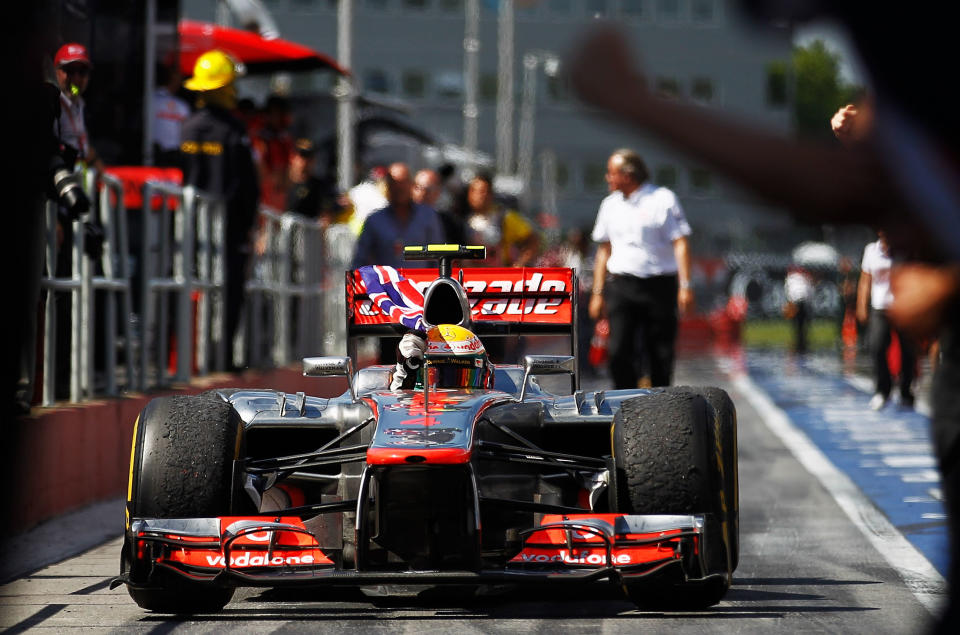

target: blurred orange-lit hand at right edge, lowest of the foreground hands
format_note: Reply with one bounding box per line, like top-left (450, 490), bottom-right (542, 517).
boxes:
top-left (887, 263), bottom-right (960, 338)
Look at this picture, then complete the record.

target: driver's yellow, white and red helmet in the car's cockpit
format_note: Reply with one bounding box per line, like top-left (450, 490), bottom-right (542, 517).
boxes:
top-left (425, 324), bottom-right (493, 388)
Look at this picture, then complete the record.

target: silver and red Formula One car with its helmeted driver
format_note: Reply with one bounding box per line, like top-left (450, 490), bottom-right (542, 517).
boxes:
top-left (114, 245), bottom-right (739, 613)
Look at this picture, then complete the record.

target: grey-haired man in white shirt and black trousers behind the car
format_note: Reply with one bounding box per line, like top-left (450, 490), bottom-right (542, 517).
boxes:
top-left (589, 149), bottom-right (693, 388)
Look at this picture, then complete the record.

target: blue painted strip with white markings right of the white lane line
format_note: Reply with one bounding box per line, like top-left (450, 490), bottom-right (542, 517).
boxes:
top-left (746, 352), bottom-right (948, 576)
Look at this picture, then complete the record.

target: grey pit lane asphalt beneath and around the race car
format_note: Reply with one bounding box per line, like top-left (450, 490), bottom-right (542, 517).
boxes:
top-left (0, 350), bottom-right (942, 635)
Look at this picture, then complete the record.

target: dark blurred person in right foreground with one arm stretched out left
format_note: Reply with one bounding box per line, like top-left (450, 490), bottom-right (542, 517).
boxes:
top-left (567, 17), bottom-right (960, 633)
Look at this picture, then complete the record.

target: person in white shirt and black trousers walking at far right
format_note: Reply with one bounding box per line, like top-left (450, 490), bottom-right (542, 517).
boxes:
top-left (857, 231), bottom-right (916, 410)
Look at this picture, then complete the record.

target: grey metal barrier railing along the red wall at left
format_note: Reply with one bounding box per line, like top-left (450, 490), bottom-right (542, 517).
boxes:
top-left (34, 170), bottom-right (356, 406)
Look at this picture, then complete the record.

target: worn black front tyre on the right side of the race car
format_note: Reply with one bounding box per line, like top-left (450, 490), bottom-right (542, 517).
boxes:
top-left (613, 391), bottom-right (731, 610)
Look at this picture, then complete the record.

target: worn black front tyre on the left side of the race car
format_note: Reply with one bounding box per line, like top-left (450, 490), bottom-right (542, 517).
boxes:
top-left (123, 395), bottom-right (243, 614)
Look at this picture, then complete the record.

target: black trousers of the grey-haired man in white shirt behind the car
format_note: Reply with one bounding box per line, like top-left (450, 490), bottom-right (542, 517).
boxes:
top-left (605, 275), bottom-right (677, 388)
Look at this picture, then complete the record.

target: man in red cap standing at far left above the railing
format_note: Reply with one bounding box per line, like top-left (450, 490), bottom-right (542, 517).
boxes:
top-left (53, 42), bottom-right (103, 170)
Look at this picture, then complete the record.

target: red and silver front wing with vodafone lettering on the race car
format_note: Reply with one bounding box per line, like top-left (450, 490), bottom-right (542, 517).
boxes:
top-left (112, 513), bottom-right (712, 588)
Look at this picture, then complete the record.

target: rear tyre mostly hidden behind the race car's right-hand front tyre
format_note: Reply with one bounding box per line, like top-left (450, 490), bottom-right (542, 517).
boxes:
top-left (667, 386), bottom-right (740, 571)
